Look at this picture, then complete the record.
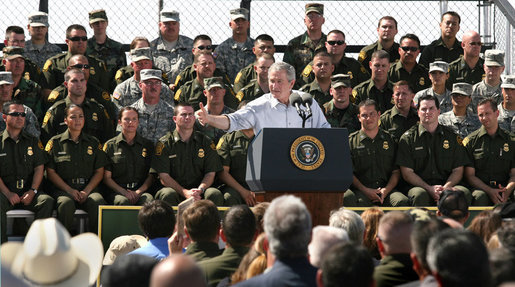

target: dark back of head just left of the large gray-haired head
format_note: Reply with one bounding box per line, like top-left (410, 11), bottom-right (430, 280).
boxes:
top-left (222, 205), bottom-right (256, 247)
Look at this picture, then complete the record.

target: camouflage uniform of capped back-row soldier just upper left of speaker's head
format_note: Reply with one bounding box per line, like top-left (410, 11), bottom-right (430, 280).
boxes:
top-left (214, 37), bottom-right (256, 82)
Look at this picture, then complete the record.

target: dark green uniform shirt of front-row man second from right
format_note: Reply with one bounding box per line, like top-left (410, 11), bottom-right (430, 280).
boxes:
top-left (396, 124), bottom-right (469, 185)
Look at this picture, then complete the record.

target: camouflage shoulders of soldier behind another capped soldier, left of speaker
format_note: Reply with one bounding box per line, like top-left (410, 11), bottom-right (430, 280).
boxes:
top-left (112, 77), bottom-right (175, 110)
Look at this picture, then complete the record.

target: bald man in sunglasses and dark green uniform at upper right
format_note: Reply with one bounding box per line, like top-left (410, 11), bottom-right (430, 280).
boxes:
top-left (447, 31), bottom-right (485, 89)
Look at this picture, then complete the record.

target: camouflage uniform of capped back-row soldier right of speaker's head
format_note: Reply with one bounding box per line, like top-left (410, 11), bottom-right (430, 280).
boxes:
top-left (283, 32), bottom-right (327, 79)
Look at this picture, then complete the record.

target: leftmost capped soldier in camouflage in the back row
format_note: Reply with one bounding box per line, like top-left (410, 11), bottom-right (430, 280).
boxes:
top-left (25, 11), bottom-right (62, 69)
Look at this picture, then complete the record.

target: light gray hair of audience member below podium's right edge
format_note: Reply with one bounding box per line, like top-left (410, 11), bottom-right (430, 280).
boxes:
top-left (329, 207), bottom-right (365, 245)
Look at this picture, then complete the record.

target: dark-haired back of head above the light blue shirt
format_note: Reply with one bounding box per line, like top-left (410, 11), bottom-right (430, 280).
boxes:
top-left (138, 200), bottom-right (175, 239)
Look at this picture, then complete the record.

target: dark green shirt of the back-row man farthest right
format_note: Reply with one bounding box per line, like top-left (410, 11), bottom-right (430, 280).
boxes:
top-left (418, 37), bottom-right (463, 69)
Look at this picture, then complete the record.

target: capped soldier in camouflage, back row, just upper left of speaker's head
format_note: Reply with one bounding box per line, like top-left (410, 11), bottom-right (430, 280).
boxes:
top-left (215, 8), bottom-right (256, 82)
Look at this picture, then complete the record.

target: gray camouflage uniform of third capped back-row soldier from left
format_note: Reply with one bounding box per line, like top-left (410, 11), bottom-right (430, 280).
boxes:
top-left (150, 35), bottom-right (193, 83)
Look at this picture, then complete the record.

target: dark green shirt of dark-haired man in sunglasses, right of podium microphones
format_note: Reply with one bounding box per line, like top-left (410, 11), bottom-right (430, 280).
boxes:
top-left (388, 61), bottom-right (431, 93)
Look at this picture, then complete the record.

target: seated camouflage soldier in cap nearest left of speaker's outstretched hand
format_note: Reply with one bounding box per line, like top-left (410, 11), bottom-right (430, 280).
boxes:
top-left (130, 69), bottom-right (175, 143)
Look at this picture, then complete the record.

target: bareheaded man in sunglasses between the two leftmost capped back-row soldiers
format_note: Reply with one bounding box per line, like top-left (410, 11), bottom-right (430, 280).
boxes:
top-left (43, 24), bottom-right (109, 93)
